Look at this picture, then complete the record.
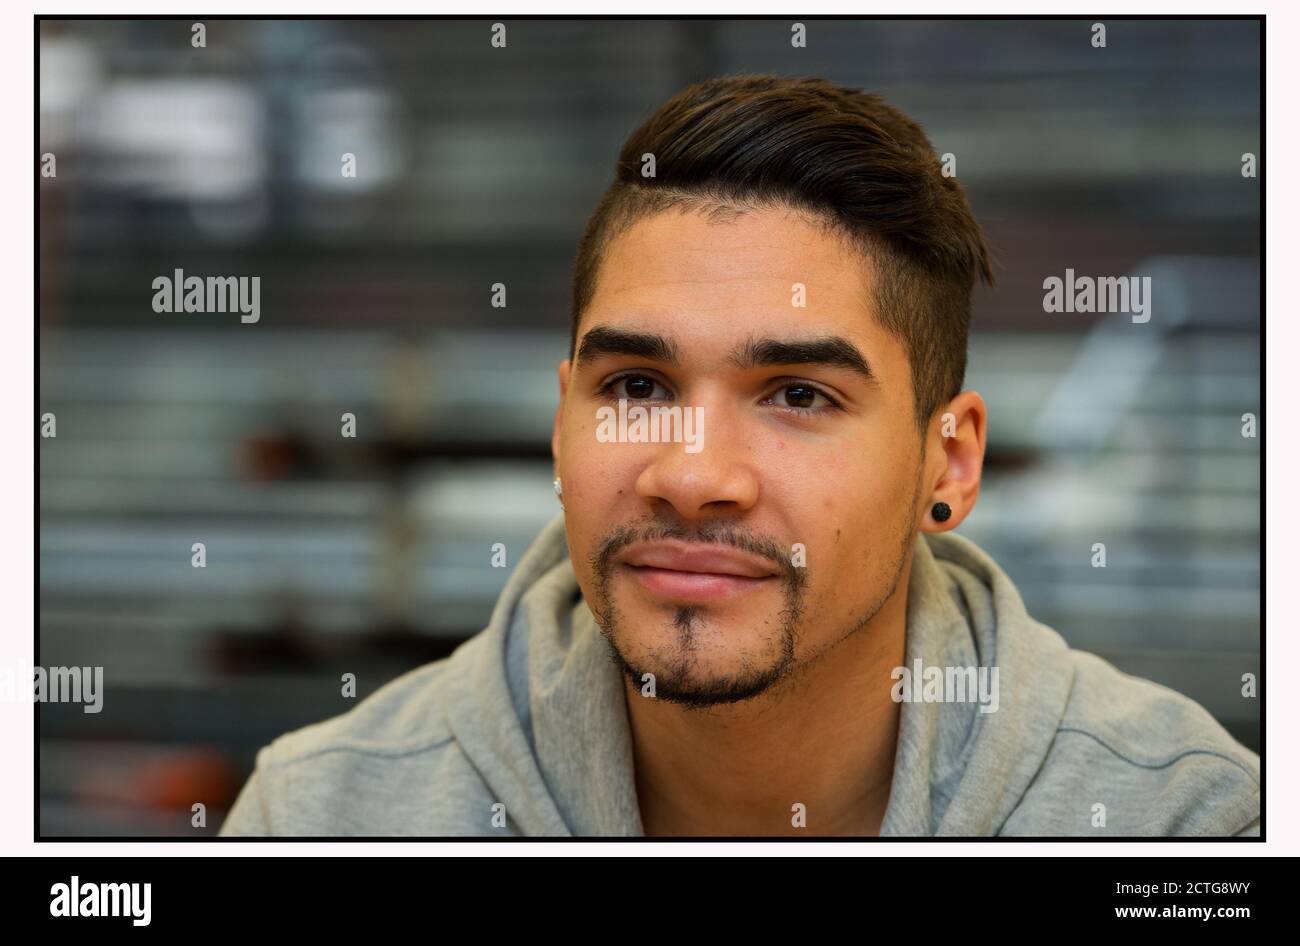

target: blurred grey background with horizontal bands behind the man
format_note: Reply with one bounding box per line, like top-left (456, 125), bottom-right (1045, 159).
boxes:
top-left (38, 18), bottom-right (1262, 837)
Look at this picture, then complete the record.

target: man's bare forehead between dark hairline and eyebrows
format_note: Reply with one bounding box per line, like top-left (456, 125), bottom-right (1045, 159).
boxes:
top-left (580, 208), bottom-right (905, 373)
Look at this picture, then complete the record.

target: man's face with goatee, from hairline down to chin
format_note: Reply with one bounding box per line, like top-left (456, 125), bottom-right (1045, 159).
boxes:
top-left (553, 209), bottom-right (922, 706)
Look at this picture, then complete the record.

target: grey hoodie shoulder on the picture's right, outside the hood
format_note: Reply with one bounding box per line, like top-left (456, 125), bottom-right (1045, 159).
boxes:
top-left (1006, 650), bottom-right (1260, 837)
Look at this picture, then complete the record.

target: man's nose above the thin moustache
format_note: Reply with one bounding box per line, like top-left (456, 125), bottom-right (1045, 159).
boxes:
top-left (636, 409), bottom-right (758, 521)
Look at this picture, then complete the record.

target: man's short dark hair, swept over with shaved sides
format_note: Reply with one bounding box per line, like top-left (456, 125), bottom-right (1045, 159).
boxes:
top-left (569, 74), bottom-right (993, 430)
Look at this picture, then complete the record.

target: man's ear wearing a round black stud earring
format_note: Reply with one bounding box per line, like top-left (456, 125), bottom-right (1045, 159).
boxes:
top-left (920, 391), bottom-right (988, 533)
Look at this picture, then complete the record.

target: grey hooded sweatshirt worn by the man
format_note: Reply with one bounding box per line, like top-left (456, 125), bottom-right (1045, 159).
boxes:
top-left (221, 517), bottom-right (1260, 838)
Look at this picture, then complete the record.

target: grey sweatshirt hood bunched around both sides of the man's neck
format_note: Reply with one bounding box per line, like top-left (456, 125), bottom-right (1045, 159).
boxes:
top-left (445, 517), bottom-right (1073, 836)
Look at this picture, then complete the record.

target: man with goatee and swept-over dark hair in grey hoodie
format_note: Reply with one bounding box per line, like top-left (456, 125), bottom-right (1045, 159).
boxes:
top-left (222, 75), bottom-right (1260, 838)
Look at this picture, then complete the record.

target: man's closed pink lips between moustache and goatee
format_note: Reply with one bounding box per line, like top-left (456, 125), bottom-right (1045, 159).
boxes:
top-left (621, 542), bottom-right (776, 602)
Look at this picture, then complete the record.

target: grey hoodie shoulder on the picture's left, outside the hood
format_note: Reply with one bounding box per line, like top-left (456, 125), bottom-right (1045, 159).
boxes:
top-left (221, 649), bottom-right (490, 837)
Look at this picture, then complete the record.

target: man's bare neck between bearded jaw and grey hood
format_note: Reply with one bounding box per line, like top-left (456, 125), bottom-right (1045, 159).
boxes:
top-left (624, 561), bottom-right (911, 837)
